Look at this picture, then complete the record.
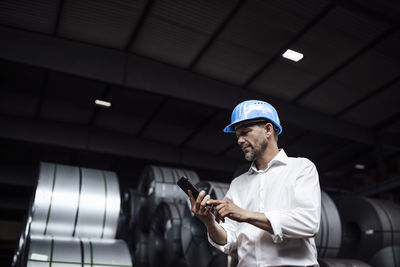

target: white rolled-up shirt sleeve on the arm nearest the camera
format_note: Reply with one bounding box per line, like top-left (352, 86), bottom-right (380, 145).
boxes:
top-left (264, 160), bottom-right (321, 243)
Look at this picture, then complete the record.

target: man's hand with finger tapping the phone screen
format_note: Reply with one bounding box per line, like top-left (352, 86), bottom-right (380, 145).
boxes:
top-left (206, 199), bottom-right (249, 222)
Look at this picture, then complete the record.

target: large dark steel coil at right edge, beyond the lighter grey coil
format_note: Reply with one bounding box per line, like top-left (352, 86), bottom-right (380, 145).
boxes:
top-left (335, 196), bottom-right (400, 262)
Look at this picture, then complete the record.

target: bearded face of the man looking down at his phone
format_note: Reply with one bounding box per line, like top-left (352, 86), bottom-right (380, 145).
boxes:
top-left (235, 122), bottom-right (268, 161)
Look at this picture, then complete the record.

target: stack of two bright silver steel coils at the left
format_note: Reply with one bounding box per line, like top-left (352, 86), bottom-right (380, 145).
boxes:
top-left (14, 163), bottom-right (132, 267)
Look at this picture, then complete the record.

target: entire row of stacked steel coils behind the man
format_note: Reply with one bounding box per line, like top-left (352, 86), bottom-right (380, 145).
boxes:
top-left (13, 163), bottom-right (400, 267)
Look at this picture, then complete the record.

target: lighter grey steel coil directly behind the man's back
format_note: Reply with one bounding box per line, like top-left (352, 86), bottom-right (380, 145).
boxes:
top-left (315, 191), bottom-right (342, 258)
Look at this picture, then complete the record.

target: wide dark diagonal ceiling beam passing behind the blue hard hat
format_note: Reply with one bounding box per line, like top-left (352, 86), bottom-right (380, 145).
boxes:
top-left (0, 27), bottom-right (373, 144)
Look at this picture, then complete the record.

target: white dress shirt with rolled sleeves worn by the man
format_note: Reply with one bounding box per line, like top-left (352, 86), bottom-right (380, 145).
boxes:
top-left (209, 149), bottom-right (321, 266)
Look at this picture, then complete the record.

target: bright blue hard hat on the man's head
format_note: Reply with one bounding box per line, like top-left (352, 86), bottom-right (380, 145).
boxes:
top-left (224, 100), bottom-right (282, 135)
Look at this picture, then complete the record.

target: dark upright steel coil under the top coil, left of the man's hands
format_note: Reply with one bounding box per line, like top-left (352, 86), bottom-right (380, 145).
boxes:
top-left (148, 202), bottom-right (188, 267)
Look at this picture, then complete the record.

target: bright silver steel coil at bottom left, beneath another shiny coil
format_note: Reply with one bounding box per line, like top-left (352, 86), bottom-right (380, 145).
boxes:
top-left (27, 236), bottom-right (132, 267)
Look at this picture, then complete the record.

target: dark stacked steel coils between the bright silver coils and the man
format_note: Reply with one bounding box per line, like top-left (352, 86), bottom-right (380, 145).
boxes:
top-left (131, 165), bottom-right (233, 267)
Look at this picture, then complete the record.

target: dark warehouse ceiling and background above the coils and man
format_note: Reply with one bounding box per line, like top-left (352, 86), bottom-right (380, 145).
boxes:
top-left (0, 0), bottom-right (400, 266)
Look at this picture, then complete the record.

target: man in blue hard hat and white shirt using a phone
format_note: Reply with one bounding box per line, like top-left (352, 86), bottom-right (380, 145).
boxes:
top-left (189, 100), bottom-right (321, 266)
